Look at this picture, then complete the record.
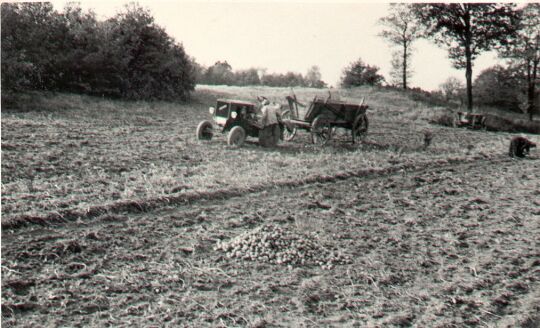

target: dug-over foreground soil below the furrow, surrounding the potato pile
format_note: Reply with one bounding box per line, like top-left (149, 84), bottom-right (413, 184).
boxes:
top-left (2, 157), bottom-right (540, 327)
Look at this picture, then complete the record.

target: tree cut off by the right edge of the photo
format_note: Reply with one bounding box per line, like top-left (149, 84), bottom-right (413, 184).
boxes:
top-left (500, 3), bottom-right (540, 120)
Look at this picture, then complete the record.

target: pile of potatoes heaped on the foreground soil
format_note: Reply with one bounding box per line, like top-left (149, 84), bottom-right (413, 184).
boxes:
top-left (216, 225), bottom-right (351, 269)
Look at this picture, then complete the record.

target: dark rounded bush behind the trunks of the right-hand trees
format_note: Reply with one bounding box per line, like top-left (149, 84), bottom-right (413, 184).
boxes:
top-left (474, 65), bottom-right (524, 112)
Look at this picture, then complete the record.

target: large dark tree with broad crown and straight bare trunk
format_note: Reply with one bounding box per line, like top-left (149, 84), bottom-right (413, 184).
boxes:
top-left (412, 3), bottom-right (518, 110)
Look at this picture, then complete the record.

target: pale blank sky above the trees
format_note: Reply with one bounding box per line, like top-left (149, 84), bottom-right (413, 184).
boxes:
top-left (53, 0), bottom-right (510, 90)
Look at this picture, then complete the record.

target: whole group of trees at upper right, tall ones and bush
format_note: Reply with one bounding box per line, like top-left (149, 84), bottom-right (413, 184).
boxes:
top-left (379, 2), bottom-right (540, 120)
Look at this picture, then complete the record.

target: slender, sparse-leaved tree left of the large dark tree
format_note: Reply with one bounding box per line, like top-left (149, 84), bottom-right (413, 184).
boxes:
top-left (379, 3), bottom-right (420, 89)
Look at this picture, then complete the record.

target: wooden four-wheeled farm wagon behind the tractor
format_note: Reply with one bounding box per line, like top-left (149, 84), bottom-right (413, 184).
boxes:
top-left (281, 96), bottom-right (368, 146)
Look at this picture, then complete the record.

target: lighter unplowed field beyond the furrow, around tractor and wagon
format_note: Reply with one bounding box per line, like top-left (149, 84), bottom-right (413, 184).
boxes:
top-left (2, 88), bottom-right (524, 227)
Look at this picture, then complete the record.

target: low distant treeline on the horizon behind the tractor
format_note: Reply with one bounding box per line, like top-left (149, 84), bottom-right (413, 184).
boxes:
top-left (195, 61), bottom-right (326, 88)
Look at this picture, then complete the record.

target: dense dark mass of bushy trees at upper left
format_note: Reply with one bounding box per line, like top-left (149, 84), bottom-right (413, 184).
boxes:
top-left (1, 2), bottom-right (195, 100)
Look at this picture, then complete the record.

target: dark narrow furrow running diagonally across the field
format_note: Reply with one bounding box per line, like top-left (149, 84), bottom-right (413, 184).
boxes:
top-left (2, 156), bottom-right (509, 229)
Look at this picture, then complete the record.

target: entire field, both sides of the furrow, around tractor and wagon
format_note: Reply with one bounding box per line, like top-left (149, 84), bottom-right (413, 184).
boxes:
top-left (2, 86), bottom-right (540, 327)
